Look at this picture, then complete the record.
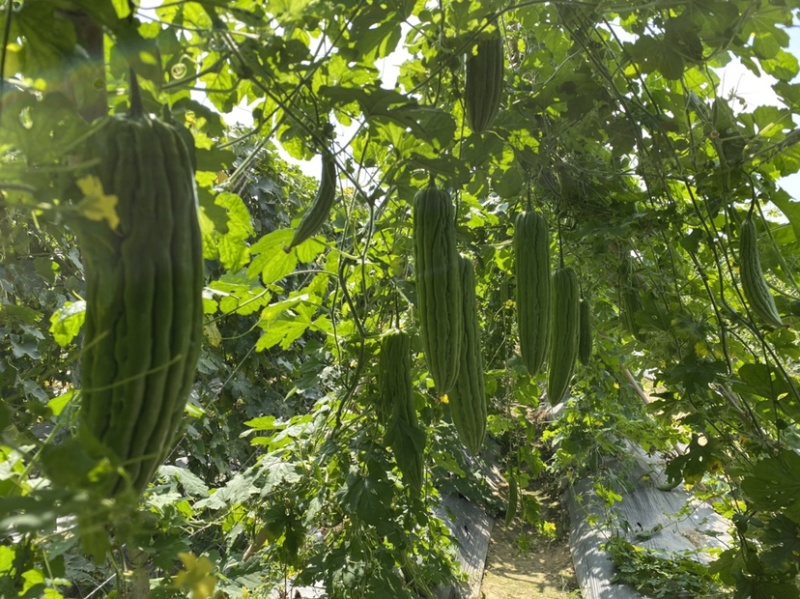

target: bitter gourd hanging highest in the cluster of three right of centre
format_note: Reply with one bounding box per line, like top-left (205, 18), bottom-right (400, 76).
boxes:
top-left (514, 211), bottom-right (550, 376)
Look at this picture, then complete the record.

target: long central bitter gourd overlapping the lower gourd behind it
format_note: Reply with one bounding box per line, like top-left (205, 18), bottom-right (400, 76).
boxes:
top-left (413, 182), bottom-right (463, 395)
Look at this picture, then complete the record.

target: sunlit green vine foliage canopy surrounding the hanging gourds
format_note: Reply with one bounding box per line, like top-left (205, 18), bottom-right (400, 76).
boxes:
top-left (0, 0), bottom-right (800, 598)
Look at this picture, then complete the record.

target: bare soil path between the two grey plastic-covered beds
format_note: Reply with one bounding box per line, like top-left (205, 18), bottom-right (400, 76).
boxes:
top-left (481, 492), bottom-right (581, 599)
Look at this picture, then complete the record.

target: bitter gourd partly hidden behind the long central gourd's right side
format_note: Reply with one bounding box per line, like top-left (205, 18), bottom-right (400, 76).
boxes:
top-left (448, 256), bottom-right (487, 455)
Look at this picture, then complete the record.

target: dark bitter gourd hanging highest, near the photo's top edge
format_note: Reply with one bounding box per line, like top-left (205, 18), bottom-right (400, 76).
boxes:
top-left (464, 29), bottom-right (504, 133)
